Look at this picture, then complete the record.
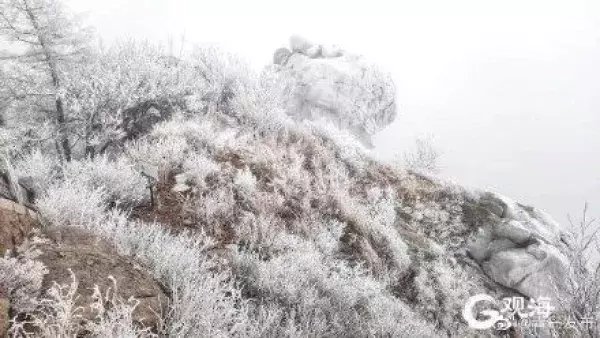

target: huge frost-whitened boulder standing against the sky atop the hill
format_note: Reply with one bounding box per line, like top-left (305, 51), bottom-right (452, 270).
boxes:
top-left (273, 36), bottom-right (396, 146)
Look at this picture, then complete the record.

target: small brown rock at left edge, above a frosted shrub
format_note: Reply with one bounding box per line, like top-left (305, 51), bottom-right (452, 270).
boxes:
top-left (0, 198), bottom-right (39, 255)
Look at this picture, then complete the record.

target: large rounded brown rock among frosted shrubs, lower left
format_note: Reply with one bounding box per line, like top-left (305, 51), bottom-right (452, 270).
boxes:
top-left (37, 227), bottom-right (168, 329)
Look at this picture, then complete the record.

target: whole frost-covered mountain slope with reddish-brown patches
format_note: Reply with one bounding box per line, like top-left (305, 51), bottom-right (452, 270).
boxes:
top-left (0, 37), bottom-right (568, 337)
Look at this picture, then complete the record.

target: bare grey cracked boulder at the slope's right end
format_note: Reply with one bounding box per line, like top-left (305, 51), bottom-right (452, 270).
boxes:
top-left (467, 193), bottom-right (568, 299)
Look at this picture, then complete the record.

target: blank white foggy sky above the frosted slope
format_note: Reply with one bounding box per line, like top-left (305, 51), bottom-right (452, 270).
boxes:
top-left (69, 0), bottom-right (600, 222)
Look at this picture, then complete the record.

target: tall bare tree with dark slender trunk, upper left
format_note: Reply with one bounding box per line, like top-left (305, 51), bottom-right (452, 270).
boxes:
top-left (0, 0), bottom-right (87, 161)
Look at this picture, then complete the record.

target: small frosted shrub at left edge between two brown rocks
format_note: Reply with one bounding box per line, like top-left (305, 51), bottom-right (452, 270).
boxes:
top-left (0, 254), bottom-right (48, 312)
